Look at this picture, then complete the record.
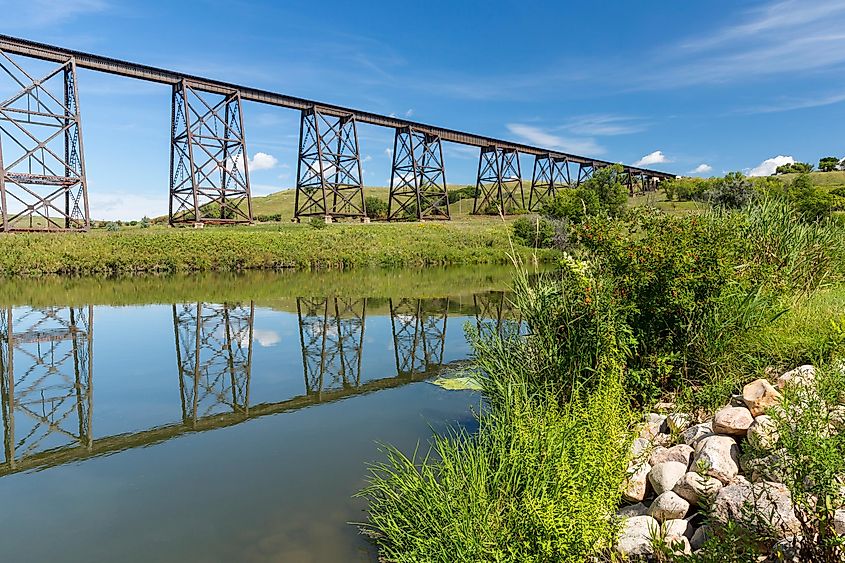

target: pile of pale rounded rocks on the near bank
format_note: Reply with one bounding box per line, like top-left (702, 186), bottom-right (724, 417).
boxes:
top-left (616, 366), bottom-right (845, 558)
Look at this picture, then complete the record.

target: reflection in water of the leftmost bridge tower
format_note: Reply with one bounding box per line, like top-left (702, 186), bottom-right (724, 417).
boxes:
top-left (0, 306), bottom-right (94, 469)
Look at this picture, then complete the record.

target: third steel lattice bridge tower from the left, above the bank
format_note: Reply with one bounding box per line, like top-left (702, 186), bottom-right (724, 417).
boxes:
top-left (294, 107), bottom-right (367, 219)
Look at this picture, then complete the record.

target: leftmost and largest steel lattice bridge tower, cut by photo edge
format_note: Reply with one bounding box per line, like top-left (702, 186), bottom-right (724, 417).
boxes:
top-left (0, 51), bottom-right (91, 231)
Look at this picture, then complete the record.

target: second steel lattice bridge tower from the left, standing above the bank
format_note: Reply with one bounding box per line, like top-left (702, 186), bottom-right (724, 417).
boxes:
top-left (169, 80), bottom-right (252, 225)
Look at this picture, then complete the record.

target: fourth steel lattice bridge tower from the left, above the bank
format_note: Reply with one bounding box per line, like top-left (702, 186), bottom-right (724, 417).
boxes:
top-left (387, 127), bottom-right (450, 221)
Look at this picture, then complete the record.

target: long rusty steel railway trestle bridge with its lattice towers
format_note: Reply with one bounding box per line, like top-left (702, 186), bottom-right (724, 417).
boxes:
top-left (0, 35), bottom-right (673, 232)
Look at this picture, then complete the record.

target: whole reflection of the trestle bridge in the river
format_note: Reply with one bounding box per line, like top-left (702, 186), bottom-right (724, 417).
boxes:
top-left (0, 292), bottom-right (521, 476)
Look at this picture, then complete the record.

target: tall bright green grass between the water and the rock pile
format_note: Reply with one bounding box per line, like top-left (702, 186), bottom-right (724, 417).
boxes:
top-left (361, 268), bottom-right (630, 563)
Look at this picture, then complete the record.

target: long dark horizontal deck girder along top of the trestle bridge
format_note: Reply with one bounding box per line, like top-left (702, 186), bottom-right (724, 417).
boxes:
top-left (0, 35), bottom-right (674, 178)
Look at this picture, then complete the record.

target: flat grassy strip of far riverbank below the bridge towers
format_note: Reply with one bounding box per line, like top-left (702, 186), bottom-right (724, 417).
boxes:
top-left (0, 218), bottom-right (550, 276)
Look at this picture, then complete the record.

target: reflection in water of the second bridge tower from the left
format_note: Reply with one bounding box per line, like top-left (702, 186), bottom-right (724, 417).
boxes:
top-left (173, 302), bottom-right (255, 425)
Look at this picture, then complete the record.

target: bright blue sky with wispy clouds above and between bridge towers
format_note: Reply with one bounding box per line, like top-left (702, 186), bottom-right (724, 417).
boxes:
top-left (0, 0), bottom-right (845, 218)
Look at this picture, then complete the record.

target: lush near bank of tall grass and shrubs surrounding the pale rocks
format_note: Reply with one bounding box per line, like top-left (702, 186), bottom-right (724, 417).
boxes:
top-left (362, 171), bottom-right (845, 563)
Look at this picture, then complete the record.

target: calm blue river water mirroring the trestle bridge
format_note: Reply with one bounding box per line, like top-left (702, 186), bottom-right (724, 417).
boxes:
top-left (0, 268), bottom-right (515, 563)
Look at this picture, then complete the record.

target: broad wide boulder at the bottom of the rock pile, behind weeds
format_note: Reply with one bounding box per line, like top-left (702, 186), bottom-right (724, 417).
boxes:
top-left (710, 481), bottom-right (801, 538)
